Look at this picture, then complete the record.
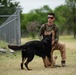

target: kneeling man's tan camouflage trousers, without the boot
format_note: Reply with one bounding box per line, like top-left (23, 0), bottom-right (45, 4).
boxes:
top-left (45, 42), bottom-right (66, 65)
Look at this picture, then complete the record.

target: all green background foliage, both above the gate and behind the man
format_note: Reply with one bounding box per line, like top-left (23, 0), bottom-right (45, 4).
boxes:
top-left (0, 0), bottom-right (76, 38)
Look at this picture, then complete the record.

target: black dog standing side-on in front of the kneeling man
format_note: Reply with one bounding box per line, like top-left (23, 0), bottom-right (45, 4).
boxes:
top-left (8, 34), bottom-right (52, 70)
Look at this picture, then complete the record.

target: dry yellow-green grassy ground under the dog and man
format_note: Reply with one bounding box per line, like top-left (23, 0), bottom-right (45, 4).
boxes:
top-left (0, 36), bottom-right (76, 75)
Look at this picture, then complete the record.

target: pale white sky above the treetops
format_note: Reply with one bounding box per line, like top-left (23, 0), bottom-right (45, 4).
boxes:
top-left (15, 0), bottom-right (65, 13)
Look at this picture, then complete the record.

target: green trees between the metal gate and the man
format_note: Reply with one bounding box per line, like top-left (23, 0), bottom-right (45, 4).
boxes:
top-left (21, 5), bottom-right (53, 36)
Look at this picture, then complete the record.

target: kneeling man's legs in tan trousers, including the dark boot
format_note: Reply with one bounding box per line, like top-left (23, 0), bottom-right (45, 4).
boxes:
top-left (46, 43), bottom-right (66, 67)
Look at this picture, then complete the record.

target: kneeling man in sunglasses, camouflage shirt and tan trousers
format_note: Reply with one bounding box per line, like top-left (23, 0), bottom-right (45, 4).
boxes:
top-left (39, 13), bottom-right (66, 67)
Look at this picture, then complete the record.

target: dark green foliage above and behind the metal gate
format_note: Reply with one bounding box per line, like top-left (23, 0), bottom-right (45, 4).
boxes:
top-left (0, 0), bottom-right (19, 25)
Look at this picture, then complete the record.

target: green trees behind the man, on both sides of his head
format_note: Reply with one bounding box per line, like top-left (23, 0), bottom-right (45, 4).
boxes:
top-left (21, 0), bottom-right (76, 36)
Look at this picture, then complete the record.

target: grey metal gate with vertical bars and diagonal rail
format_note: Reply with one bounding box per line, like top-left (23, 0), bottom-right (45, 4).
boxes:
top-left (0, 8), bottom-right (21, 45)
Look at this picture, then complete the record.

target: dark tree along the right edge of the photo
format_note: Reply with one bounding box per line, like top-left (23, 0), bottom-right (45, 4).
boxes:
top-left (66, 0), bottom-right (76, 38)
